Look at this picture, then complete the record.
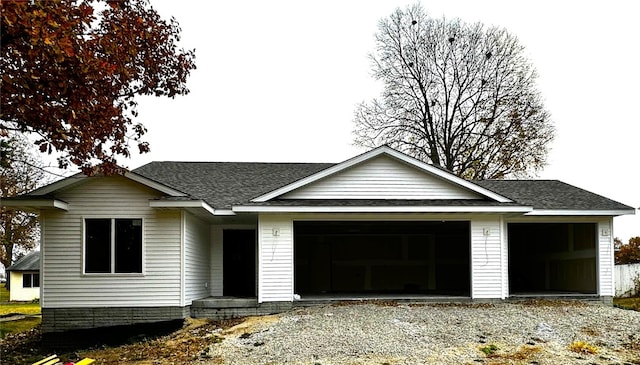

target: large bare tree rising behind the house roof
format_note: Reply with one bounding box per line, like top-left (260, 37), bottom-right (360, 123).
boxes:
top-left (354, 5), bottom-right (554, 179)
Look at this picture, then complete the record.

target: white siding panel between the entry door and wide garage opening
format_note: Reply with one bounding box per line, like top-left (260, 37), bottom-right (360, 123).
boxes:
top-left (258, 215), bottom-right (293, 303)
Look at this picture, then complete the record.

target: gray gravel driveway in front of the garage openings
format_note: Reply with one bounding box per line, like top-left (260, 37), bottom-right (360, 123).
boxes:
top-left (203, 302), bottom-right (640, 365)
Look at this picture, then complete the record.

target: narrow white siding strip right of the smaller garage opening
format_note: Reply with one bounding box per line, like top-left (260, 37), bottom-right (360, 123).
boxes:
top-left (596, 218), bottom-right (616, 296)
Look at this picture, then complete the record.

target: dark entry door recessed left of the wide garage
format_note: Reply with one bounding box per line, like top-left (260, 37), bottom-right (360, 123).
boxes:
top-left (222, 229), bottom-right (256, 297)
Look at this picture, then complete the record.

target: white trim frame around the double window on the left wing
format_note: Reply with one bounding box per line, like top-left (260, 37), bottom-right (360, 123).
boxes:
top-left (81, 215), bottom-right (146, 277)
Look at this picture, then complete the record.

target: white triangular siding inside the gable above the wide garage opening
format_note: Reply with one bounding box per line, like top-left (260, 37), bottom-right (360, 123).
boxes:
top-left (281, 156), bottom-right (479, 199)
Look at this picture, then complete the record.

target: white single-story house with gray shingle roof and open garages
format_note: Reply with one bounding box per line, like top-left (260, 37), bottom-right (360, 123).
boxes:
top-left (3, 146), bottom-right (635, 332)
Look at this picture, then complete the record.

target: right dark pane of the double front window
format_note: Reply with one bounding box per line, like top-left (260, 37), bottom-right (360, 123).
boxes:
top-left (116, 219), bottom-right (142, 273)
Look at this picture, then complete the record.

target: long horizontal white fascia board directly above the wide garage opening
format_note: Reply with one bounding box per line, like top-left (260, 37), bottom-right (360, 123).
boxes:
top-left (233, 205), bottom-right (533, 213)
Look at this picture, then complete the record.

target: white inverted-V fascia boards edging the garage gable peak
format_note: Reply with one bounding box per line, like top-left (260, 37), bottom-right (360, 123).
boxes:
top-left (251, 146), bottom-right (512, 203)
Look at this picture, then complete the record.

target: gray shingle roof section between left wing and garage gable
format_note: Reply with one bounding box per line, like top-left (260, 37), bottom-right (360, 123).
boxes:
top-left (133, 161), bottom-right (334, 209)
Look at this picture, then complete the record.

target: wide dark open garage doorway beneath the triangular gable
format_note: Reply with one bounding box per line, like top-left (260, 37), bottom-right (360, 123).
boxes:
top-left (294, 221), bottom-right (470, 297)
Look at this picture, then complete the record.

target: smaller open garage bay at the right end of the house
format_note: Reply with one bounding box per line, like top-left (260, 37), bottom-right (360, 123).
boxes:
top-left (508, 223), bottom-right (598, 296)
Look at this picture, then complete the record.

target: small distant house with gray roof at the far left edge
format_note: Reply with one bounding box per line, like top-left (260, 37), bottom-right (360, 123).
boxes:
top-left (6, 251), bottom-right (40, 301)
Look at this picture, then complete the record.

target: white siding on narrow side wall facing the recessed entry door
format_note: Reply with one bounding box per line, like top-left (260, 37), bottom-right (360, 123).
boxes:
top-left (183, 213), bottom-right (210, 305)
